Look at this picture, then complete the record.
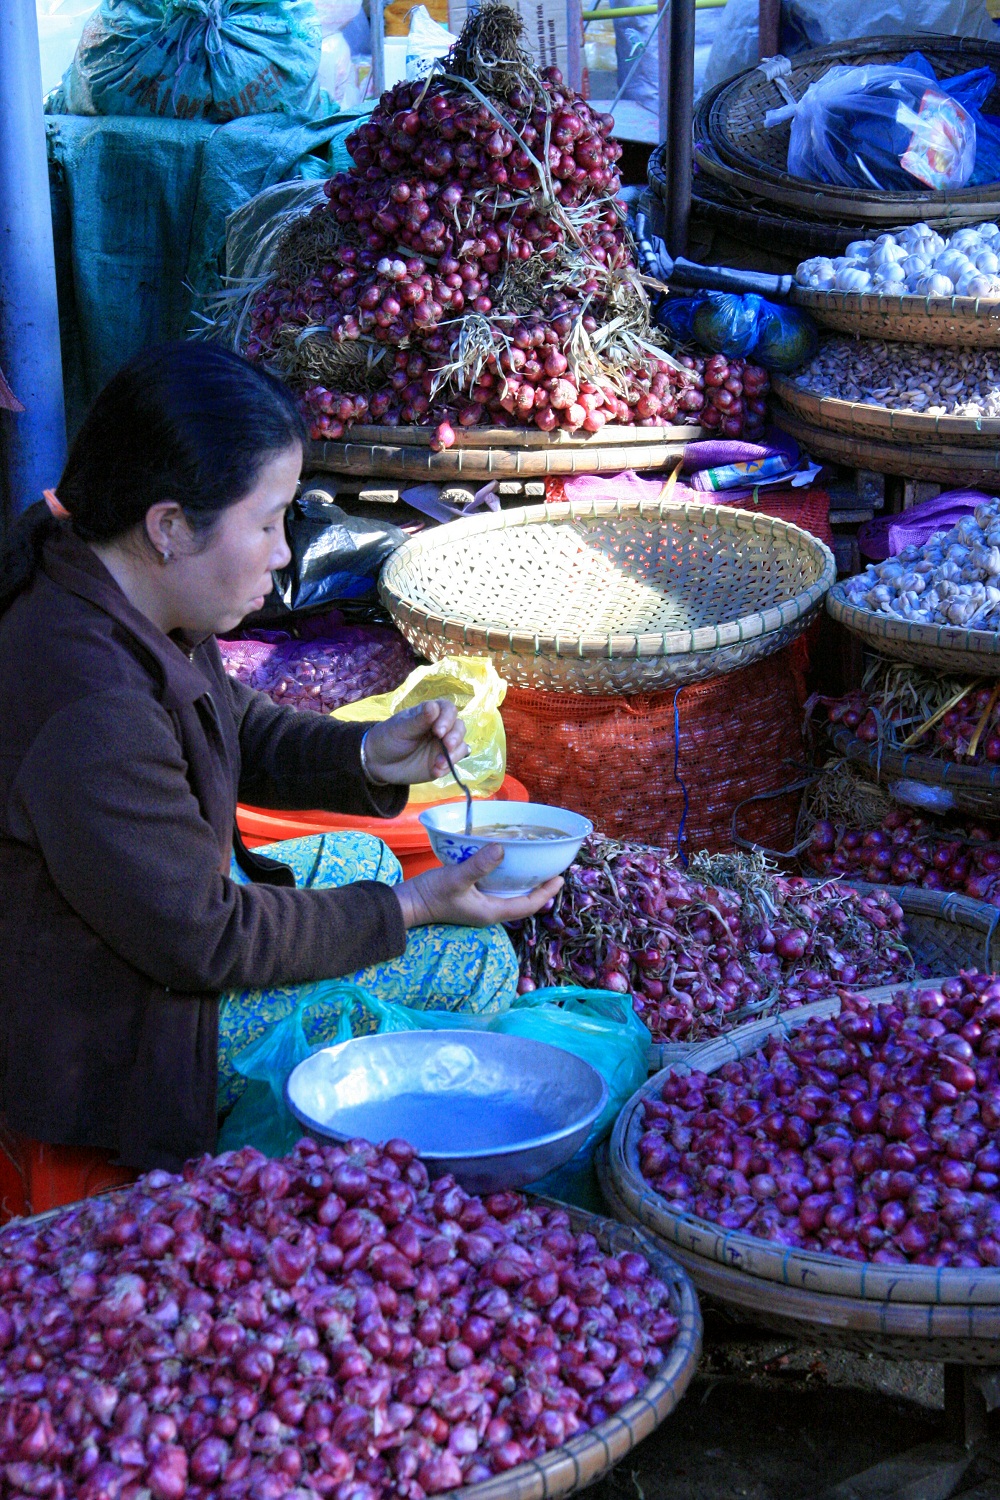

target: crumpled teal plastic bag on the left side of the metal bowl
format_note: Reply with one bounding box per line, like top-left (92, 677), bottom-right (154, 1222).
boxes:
top-left (217, 980), bottom-right (375, 1157)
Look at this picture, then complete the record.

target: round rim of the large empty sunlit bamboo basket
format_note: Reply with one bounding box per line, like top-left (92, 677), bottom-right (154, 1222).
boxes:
top-left (378, 500), bottom-right (837, 660)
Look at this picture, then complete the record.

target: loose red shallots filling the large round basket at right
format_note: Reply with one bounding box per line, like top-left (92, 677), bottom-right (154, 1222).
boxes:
top-left (639, 974), bottom-right (1000, 1271)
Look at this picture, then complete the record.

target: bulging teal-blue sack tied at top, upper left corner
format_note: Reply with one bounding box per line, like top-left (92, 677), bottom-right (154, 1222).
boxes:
top-left (63, 0), bottom-right (322, 125)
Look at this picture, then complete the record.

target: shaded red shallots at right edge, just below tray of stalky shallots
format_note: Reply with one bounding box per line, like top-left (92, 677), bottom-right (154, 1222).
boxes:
top-left (807, 807), bottom-right (1000, 906)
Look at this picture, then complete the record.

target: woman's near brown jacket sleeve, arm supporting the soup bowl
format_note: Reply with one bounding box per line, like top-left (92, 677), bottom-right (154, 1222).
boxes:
top-left (9, 690), bottom-right (406, 993)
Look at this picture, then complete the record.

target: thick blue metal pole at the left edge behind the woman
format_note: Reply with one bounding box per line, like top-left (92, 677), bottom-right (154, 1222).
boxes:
top-left (0, 0), bottom-right (66, 513)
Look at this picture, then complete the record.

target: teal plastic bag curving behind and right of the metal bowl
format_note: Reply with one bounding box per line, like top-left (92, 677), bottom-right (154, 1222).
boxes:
top-left (355, 986), bottom-right (652, 1212)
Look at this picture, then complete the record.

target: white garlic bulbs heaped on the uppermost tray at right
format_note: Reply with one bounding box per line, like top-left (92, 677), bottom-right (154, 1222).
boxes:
top-left (795, 224), bottom-right (1000, 297)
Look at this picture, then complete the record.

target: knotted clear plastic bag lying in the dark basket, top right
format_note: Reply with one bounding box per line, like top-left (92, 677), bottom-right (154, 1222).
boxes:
top-left (766, 63), bottom-right (976, 192)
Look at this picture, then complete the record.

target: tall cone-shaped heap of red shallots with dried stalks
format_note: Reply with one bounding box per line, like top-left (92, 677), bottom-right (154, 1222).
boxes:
top-left (244, 0), bottom-right (766, 450)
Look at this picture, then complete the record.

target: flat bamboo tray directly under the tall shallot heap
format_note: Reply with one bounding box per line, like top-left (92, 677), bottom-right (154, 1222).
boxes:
top-left (309, 426), bottom-right (703, 483)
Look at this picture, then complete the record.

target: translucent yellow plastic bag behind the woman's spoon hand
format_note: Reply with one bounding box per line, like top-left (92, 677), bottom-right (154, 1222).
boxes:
top-left (333, 657), bottom-right (507, 803)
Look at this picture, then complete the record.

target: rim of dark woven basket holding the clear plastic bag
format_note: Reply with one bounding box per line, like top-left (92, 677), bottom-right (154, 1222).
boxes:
top-left (696, 32), bottom-right (1000, 212)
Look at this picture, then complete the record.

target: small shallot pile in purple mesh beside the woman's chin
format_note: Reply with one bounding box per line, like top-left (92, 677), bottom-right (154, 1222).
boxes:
top-left (219, 626), bottom-right (417, 714)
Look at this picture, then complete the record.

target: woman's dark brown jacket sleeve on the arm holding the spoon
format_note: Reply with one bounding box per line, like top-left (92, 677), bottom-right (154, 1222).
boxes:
top-left (228, 678), bottom-right (409, 818)
